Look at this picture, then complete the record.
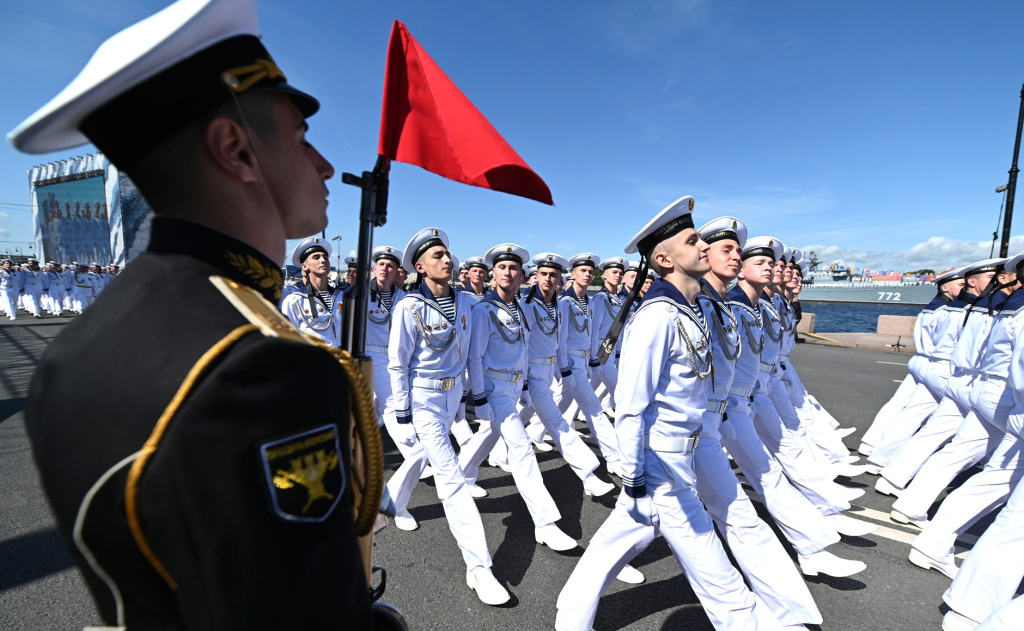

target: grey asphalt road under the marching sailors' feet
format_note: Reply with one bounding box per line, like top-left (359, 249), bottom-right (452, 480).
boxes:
top-left (0, 318), bottom-right (990, 631)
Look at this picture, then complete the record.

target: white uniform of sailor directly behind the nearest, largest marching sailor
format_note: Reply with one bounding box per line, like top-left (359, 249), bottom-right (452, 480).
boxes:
top-left (693, 282), bottom-right (821, 625)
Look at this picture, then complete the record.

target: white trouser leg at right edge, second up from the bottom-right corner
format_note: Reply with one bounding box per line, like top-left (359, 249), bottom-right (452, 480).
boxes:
top-left (912, 407), bottom-right (1024, 562)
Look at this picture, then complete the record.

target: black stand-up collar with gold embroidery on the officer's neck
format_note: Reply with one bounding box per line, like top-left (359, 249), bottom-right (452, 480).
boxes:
top-left (146, 216), bottom-right (285, 304)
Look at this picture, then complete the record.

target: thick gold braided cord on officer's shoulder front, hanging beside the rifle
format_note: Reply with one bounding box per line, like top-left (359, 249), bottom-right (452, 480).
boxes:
top-left (315, 340), bottom-right (385, 537)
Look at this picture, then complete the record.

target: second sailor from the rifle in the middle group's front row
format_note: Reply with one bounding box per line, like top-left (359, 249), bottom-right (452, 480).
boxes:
top-left (459, 243), bottom-right (577, 552)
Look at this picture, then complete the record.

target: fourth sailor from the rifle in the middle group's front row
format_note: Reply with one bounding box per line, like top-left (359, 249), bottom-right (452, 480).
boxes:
top-left (556, 252), bottom-right (621, 475)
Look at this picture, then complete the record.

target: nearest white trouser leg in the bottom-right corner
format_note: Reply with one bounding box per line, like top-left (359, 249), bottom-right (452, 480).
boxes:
top-left (942, 465), bottom-right (1024, 628)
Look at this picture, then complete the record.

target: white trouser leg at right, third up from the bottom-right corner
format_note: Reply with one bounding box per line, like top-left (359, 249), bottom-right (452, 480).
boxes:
top-left (893, 380), bottom-right (1014, 519)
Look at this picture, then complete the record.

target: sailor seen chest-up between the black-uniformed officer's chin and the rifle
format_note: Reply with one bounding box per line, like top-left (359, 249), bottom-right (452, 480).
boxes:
top-left (281, 237), bottom-right (342, 346)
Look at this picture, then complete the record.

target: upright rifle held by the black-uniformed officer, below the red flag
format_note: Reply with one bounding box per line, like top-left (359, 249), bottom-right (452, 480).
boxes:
top-left (339, 156), bottom-right (409, 631)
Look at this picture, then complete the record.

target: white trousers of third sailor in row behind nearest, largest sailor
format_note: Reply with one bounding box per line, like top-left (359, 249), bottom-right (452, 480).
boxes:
top-left (724, 394), bottom-right (840, 556)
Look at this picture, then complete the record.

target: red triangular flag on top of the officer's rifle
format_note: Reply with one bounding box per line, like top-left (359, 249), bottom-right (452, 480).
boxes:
top-left (377, 19), bottom-right (554, 206)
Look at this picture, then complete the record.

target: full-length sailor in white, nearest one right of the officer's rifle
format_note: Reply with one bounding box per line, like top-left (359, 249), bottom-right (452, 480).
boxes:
top-left (388, 227), bottom-right (510, 605)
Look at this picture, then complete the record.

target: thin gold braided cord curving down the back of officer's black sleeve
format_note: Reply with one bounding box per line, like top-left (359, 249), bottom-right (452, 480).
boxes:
top-left (125, 325), bottom-right (259, 590)
